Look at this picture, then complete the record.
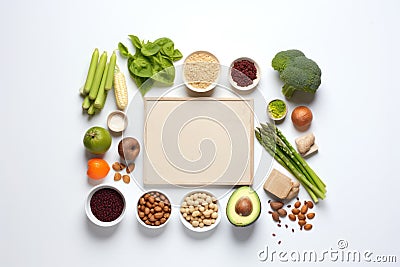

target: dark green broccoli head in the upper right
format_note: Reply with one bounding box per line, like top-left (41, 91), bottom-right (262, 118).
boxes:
top-left (272, 50), bottom-right (321, 98)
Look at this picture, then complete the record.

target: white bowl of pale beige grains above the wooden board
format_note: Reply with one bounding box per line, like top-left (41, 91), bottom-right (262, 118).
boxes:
top-left (183, 51), bottom-right (221, 94)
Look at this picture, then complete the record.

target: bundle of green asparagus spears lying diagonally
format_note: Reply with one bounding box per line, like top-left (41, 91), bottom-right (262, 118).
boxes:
top-left (255, 123), bottom-right (326, 203)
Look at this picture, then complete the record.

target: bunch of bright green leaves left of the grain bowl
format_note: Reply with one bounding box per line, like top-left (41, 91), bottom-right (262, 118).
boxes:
top-left (118, 35), bottom-right (183, 96)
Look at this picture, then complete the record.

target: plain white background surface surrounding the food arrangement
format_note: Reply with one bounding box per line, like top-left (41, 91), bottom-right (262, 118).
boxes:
top-left (0, 0), bottom-right (400, 267)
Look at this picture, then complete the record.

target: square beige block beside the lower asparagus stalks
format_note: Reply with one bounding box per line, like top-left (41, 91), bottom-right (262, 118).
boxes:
top-left (264, 169), bottom-right (293, 199)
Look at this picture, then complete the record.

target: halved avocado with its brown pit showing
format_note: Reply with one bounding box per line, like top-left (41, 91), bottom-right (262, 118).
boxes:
top-left (226, 186), bottom-right (261, 227)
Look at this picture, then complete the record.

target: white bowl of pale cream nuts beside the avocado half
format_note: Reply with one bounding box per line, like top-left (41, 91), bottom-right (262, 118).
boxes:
top-left (179, 190), bottom-right (221, 233)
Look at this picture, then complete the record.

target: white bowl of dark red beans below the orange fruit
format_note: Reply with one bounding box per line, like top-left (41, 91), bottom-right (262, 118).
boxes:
top-left (85, 184), bottom-right (126, 227)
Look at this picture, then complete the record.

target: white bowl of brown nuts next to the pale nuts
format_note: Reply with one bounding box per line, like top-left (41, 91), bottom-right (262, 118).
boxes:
top-left (136, 190), bottom-right (171, 229)
